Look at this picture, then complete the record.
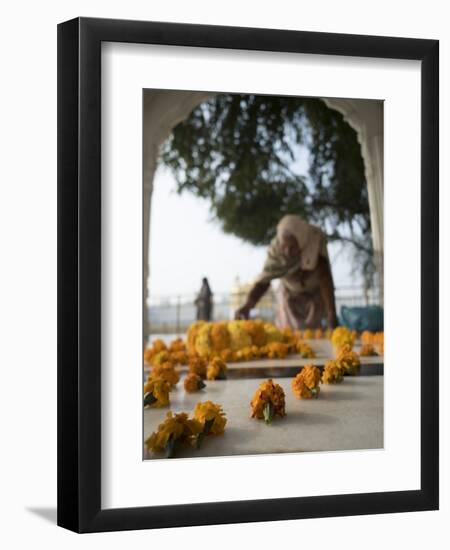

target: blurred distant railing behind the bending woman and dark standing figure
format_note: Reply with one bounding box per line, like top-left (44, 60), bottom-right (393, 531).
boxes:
top-left (147, 286), bottom-right (379, 334)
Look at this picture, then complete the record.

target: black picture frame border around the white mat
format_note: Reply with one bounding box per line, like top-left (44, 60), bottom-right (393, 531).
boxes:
top-left (57, 18), bottom-right (439, 532)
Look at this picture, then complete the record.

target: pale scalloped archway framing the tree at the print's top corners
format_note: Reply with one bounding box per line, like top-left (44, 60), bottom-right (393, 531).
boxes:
top-left (143, 90), bottom-right (384, 339)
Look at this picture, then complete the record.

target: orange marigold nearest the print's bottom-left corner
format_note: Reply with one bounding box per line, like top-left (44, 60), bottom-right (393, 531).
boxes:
top-left (145, 412), bottom-right (201, 458)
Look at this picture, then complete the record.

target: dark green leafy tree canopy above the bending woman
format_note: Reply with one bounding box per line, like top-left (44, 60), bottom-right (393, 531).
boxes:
top-left (161, 94), bottom-right (374, 282)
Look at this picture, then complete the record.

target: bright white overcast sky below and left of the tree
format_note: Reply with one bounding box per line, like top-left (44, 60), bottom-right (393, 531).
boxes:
top-left (149, 167), bottom-right (357, 297)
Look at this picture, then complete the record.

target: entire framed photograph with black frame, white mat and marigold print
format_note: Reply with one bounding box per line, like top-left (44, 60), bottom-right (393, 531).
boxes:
top-left (58, 18), bottom-right (439, 532)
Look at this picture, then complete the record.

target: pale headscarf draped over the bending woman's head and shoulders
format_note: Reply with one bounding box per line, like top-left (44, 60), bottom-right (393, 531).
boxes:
top-left (256, 214), bottom-right (328, 282)
